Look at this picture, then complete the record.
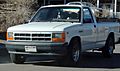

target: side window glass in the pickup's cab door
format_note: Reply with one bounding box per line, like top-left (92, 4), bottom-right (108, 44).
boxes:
top-left (83, 8), bottom-right (94, 23)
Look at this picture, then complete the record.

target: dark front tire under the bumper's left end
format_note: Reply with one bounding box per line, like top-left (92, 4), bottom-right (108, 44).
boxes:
top-left (10, 54), bottom-right (25, 64)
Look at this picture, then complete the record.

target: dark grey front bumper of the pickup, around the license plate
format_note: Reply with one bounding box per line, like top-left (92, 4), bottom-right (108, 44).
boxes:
top-left (5, 41), bottom-right (68, 55)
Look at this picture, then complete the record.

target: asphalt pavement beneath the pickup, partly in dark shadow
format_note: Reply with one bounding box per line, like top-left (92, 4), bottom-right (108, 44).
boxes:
top-left (0, 44), bottom-right (120, 71)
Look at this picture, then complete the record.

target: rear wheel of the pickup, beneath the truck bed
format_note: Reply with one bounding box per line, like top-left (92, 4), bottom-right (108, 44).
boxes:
top-left (102, 36), bottom-right (115, 58)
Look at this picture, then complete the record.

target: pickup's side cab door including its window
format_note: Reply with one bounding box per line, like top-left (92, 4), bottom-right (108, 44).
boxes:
top-left (80, 7), bottom-right (96, 50)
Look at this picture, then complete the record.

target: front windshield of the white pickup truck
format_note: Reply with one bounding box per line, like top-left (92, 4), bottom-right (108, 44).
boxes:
top-left (30, 7), bottom-right (80, 22)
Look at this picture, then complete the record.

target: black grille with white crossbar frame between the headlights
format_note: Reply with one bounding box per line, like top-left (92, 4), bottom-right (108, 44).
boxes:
top-left (14, 33), bottom-right (52, 42)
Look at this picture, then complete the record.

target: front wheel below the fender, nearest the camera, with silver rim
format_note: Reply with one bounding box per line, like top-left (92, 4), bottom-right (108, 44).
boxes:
top-left (67, 38), bottom-right (81, 66)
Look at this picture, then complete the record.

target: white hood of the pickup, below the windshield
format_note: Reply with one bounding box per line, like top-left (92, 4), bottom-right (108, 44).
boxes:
top-left (8, 22), bottom-right (77, 32)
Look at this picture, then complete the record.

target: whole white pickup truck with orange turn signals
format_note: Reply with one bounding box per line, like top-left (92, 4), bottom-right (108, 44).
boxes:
top-left (6, 5), bottom-right (119, 65)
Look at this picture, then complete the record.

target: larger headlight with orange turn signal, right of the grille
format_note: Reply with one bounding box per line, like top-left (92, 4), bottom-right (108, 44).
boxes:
top-left (52, 32), bottom-right (65, 42)
